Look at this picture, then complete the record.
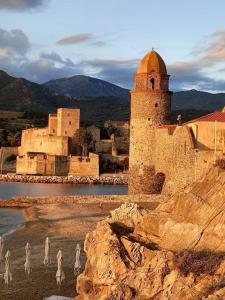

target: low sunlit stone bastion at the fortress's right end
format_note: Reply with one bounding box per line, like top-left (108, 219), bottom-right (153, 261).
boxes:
top-left (69, 153), bottom-right (99, 176)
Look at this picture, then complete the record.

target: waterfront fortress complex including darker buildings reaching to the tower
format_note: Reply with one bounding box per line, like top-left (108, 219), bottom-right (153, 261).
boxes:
top-left (15, 108), bottom-right (129, 176)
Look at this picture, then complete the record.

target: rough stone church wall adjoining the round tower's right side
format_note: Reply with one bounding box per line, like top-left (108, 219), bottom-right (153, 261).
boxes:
top-left (155, 126), bottom-right (219, 193)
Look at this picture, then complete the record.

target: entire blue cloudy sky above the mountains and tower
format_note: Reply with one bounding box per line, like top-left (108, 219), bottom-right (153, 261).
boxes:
top-left (0, 0), bottom-right (225, 92)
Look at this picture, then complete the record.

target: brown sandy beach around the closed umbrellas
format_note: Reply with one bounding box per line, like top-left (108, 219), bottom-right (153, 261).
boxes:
top-left (0, 201), bottom-right (157, 300)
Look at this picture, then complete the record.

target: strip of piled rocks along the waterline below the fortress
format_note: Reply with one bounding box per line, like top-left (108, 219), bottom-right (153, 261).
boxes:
top-left (0, 174), bottom-right (128, 185)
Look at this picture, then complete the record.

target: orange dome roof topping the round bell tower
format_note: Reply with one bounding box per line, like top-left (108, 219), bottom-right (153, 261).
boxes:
top-left (137, 50), bottom-right (167, 74)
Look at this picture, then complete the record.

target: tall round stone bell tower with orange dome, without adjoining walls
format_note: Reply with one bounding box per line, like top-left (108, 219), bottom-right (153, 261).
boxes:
top-left (129, 50), bottom-right (172, 194)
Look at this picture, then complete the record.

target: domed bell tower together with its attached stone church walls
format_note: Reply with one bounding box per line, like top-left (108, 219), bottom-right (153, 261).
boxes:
top-left (129, 50), bottom-right (225, 194)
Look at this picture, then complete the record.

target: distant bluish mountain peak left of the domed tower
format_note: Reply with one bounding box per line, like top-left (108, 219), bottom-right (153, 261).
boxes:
top-left (44, 75), bottom-right (129, 99)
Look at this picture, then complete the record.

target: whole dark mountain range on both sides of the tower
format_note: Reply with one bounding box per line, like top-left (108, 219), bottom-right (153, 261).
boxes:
top-left (0, 71), bottom-right (225, 122)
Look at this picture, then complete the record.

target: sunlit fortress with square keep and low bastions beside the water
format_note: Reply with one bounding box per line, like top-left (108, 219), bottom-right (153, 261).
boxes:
top-left (16, 108), bottom-right (99, 176)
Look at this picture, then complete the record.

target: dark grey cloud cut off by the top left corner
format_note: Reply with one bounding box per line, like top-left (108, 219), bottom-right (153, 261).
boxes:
top-left (0, 0), bottom-right (49, 10)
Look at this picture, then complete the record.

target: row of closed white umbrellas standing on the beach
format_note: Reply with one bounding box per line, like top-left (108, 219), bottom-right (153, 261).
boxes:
top-left (0, 236), bottom-right (81, 287)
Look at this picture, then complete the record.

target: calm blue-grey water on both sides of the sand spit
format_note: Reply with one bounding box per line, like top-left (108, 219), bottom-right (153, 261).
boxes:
top-left (0, 183), bottom-right (127, 235)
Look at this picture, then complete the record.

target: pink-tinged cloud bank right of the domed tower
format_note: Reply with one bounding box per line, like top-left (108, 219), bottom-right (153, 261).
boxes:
top-left (165, 30), bottom-right (225, 92)
